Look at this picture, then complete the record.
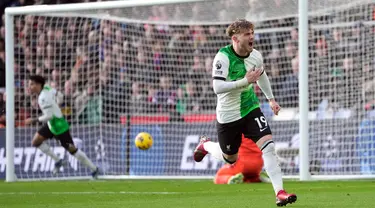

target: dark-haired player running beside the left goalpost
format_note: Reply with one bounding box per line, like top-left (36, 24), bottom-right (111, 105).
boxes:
top-left (25, 75), bottom-right (99, 179)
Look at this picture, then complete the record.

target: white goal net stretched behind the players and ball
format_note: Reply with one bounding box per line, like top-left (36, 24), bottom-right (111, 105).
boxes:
top-left (0, 0), bottom-right (375, 179)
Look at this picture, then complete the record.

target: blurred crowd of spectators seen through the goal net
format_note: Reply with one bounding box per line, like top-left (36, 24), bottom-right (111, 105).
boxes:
top-left (0, 0), bottom-right (375, 126)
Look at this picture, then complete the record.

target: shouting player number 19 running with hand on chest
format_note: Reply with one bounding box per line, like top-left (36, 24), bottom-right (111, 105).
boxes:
top-left (194, 19), bottom-right (297, 206)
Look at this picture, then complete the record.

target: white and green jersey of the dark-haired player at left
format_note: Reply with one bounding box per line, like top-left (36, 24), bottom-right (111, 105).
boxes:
top-left (38, 86), bottom-right (69, 135)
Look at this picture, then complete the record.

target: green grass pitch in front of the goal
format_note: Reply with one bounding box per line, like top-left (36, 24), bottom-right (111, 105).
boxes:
top-left (0, 180), bottom-right (375, 208)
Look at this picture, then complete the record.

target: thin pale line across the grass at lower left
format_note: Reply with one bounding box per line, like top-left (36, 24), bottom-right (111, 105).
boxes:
top-left (0, 191), bottom-right (185, 196)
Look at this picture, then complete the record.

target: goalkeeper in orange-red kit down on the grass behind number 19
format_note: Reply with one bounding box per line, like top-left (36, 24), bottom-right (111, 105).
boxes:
top-left (214, 136), bottom-right (270, 184)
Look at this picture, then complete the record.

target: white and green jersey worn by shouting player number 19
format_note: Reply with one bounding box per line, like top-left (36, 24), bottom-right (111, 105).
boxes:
top-left (212, 45), bottom-right (263, 123)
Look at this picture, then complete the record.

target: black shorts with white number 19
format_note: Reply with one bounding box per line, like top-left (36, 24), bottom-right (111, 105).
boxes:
top-left (216, 108), bottom-right (272, 155)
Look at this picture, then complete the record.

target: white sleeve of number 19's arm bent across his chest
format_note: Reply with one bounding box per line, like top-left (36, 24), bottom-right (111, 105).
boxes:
top-left (212, 52), bottom-right (249, 94)
